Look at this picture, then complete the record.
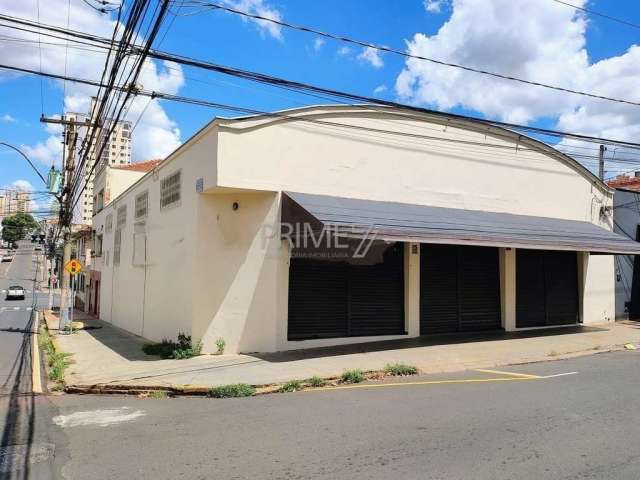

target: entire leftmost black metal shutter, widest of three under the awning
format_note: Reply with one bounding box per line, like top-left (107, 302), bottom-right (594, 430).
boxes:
top-left (287, 243), bottom-right (405, 340)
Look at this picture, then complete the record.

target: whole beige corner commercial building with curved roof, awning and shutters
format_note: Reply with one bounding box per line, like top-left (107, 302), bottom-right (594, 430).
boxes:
top-left (93, 106), bottom-right (640, 352)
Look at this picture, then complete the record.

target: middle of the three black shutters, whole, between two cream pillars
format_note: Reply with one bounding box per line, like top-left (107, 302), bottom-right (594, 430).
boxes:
top-left (420, 245), bottom-right (501, 335)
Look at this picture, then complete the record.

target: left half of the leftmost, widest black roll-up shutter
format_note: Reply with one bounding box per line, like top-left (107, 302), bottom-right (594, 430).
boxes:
top-left (288, 258), bottom-right (348, 340)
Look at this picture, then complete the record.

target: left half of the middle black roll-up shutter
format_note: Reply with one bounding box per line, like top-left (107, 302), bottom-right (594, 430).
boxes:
top-left (420, 244), bottom-right (459, 335)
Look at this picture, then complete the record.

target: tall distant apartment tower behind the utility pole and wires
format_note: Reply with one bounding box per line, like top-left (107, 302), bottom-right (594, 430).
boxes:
top-left (65, 98), bottom-right (131, 225)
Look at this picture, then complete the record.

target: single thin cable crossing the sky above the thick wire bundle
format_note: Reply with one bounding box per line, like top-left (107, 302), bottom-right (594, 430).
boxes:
top-left (182, 1), bottom-right (640, 107)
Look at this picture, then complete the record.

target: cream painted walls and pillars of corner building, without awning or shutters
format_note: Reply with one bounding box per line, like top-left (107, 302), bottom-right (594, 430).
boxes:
top-left (94, 107), bottom-right (615, 352)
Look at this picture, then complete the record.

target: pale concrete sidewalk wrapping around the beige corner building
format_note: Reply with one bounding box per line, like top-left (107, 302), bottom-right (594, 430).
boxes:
top-left (45, 313), bottom-right (640, 388)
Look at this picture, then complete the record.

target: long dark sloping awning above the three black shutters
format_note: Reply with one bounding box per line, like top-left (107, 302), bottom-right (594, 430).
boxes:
top-left (282, 192), bottom-right (640, 255)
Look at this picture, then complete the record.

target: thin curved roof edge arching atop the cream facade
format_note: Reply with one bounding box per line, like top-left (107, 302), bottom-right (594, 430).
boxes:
top-left (215, 104), bottom-right (613, 194)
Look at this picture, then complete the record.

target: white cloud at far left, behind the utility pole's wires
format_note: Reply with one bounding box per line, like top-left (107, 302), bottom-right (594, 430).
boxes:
top-left (0, 0), bottom-right (188, 166)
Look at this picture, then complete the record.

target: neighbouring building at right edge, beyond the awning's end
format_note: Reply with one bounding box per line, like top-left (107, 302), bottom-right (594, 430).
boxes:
top-left (607, 172), bottom-right (640, 320)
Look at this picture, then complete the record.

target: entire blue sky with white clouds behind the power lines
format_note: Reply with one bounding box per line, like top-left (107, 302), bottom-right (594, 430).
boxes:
top-left (0, 0), bottom-right (640, 202)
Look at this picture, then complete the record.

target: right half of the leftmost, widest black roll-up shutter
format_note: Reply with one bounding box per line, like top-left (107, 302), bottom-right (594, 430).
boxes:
top-left (348, 243), bottom-right (405, 337)
